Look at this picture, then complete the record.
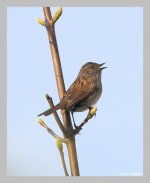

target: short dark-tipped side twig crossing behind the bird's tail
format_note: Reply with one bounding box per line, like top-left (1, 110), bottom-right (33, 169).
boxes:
top-left (45, 94), bottom-right (65, 134)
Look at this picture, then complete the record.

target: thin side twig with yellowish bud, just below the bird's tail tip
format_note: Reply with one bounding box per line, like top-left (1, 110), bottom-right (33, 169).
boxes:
top-left (37, 118), bottom-right (68, 143)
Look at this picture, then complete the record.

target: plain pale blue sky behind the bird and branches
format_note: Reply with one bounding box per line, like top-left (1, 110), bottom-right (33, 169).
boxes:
top-left (7, 7), bottom-right (143, 176)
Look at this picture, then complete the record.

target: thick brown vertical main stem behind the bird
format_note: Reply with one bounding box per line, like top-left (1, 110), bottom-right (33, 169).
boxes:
top-left (43, 7), bottom-right (79, 176)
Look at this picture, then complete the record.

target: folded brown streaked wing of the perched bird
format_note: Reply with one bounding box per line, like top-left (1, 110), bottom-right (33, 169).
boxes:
top-left (64, 76), bottom-right (96, 108)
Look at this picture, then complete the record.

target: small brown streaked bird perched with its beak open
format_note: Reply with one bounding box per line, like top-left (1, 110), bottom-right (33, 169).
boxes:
top-left (38, 62), bottom-right (107, 128)
